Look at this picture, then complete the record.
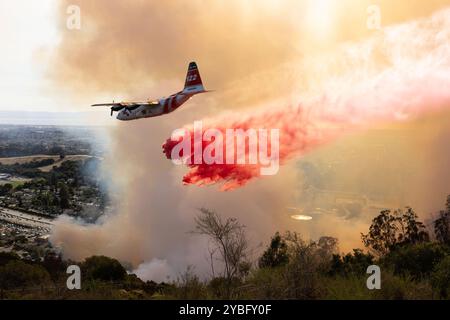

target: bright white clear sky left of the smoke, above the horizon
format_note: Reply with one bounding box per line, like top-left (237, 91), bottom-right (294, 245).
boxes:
top-left (0, 0), bottom-right (111, 125)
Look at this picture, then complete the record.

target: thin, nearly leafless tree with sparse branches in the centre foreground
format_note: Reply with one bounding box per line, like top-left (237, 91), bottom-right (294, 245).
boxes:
top-left (193, 208), bottom-right (248, 298)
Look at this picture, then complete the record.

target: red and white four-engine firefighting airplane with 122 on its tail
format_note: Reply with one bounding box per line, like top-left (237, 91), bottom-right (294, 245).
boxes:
top-left (92, 62), bottom-right (209, 120)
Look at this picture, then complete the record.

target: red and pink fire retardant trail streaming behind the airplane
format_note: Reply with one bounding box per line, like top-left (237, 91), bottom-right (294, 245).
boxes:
top-left (163, 10), bottom-right (450, 190)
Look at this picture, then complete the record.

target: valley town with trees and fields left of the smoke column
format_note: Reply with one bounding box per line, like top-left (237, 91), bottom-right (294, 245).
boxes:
top-left (0, 124), bottom-right (109, 261)
